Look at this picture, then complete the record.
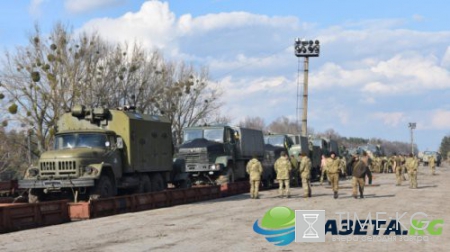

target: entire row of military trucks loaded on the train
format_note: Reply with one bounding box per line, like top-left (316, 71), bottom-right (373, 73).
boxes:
top-left (19, 105), bottom-right (348, 202)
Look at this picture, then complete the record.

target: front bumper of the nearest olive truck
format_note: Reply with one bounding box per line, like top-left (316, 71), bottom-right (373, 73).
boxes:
top-left (19, 179), bottom-right (95, 189)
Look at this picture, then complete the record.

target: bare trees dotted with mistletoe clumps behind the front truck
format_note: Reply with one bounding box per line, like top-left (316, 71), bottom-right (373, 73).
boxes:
top-left (0, 24), bottom-right (222, 151)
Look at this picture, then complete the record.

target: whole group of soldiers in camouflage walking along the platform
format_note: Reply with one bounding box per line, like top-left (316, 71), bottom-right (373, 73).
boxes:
top-left (247, 151), bottom-right (436, 199)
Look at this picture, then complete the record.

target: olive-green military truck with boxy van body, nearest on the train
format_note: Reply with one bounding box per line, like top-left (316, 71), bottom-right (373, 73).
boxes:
top-left (19, 106), bottom-right (183, 202)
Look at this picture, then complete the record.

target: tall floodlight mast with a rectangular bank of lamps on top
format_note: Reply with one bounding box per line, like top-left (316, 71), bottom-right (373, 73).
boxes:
top-left (294, 38), bottom-right (320, 137)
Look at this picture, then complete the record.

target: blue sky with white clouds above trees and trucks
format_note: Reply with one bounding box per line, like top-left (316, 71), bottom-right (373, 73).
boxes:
top-left (0, 0), bottom-right (450, 150)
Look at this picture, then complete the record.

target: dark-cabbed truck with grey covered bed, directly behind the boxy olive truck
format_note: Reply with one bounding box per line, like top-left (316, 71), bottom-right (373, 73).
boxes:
top-left (177, 125), bottom-right (264, 184)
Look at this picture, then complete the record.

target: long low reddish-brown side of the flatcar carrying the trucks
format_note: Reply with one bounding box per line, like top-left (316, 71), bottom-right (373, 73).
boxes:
top-left (0, 181), bottom-right (256, 233)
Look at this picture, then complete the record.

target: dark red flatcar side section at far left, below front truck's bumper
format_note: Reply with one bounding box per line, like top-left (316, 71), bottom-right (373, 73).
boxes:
top-left (0, 200), bottom-right (70, 233)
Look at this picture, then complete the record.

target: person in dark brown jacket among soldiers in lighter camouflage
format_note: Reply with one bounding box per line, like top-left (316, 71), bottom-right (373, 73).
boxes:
top-left (352, 152), bottom-right (372, 199)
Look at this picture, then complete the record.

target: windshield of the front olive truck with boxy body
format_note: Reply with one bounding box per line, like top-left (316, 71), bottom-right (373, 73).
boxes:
top-left (54, 133), bottom-right (109, 150)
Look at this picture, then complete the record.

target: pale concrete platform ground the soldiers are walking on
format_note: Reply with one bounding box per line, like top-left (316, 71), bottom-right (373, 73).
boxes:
top-left (0, 164), bottom-right (450, 252)
